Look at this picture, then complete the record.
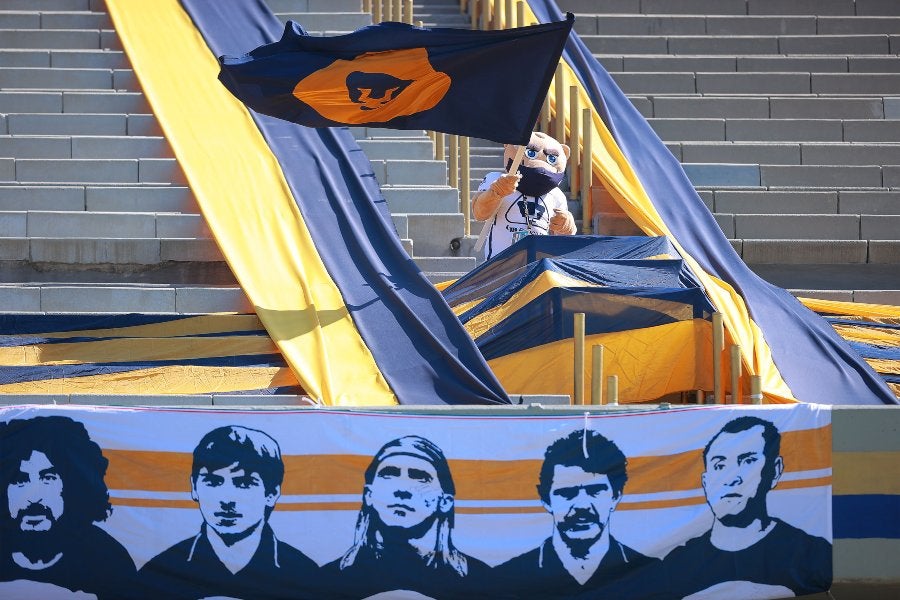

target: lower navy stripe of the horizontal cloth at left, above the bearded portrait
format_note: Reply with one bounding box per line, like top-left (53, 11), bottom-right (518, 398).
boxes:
top-left (0, 354), bottom-right (287, 385)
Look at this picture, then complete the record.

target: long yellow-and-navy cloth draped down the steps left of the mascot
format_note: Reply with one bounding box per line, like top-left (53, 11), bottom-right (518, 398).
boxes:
top-left (107, 0), bottom-right (509, 405)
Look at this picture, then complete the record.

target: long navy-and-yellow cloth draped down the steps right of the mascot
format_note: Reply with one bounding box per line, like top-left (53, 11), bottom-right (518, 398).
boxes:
top-left (528, 0), bottom-right (898, 404)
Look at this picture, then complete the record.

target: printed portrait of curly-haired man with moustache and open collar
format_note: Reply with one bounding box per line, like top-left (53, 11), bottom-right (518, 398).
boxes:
top-left (496, 430), bottom-right (659, 599)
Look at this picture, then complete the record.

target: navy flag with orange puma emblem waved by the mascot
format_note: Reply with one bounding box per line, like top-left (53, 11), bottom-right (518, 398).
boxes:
top-left (219, 13), bottom-right (575, 144)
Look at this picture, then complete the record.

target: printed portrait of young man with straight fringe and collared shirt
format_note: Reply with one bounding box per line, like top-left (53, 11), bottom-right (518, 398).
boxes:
top-left (140, 425), bottom-right (323, 599)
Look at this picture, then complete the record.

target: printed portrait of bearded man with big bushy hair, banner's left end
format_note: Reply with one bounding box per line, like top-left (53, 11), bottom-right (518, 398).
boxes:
top-left (0, 416), bottom-right (135, 599)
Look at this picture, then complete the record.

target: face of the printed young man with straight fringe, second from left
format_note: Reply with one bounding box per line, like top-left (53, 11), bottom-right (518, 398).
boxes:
top-left (192, 463), bottom-right (279, 538)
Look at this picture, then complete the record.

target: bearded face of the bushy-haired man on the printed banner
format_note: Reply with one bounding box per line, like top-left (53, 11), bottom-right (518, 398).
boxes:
top-left (6, 450), bottom-right (65, 531)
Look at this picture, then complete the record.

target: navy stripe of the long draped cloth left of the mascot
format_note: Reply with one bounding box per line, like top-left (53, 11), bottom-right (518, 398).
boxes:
top-left (182, 0), bottom-right (509, 404)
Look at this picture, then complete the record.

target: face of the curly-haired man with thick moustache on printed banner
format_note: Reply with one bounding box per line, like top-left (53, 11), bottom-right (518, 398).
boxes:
top-left (544, 465), bottom-right (621, 541)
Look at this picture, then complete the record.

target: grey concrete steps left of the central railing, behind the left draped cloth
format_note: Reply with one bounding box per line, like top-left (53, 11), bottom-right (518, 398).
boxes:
top-left (0, 0), bottom-right (475, 313)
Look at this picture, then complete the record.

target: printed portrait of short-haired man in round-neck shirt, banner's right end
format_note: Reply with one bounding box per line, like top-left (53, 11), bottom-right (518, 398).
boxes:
top-left (664, 416), bottom-right (831, 598)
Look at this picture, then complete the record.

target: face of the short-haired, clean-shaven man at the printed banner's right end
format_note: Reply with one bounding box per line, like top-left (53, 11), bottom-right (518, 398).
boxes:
top-left (702, 425), bottom-right (780, 520)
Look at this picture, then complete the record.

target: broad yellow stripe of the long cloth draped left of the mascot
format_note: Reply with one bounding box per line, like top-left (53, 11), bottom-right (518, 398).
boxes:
top-left (106, 0), bottom-right (397, 405)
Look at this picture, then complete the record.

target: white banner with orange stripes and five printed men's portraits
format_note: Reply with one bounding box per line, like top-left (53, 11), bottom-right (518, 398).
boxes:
top-left (0, 404), bottom-right (832, 600)
